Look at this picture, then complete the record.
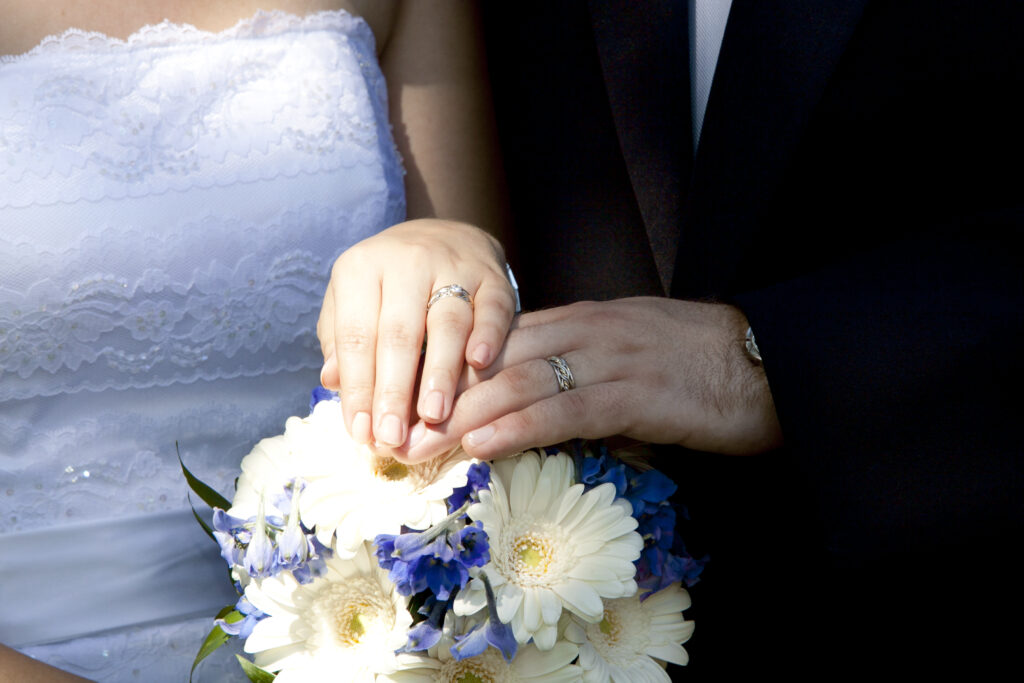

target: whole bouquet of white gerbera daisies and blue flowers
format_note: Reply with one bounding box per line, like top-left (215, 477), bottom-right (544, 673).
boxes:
top-left (182, 390), bottom-right (702, 683)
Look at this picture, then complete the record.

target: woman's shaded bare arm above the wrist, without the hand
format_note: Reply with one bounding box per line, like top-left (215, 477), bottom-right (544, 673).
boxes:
top-left (380, 0), bottom-right (508, 240)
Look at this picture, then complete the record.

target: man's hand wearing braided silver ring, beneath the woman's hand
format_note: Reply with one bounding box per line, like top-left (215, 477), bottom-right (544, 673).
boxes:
top-left (395, 298), bottom-right (782, 461)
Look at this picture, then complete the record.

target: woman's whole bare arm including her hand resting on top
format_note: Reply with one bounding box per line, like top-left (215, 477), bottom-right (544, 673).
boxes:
top-left (317, 0), bottom-right (514, 445)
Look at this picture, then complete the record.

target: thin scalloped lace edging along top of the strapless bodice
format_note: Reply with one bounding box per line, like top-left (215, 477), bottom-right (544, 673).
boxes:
top-left (0, 9), bottom-right (377, 67)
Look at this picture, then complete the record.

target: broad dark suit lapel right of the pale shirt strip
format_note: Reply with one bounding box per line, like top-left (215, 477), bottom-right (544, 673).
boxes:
top-left (672, 0), bottom-right (866, 297)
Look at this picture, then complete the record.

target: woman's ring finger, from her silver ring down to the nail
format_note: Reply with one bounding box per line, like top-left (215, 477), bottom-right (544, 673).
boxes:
top-left (417, 286), bottom-right (473, 423)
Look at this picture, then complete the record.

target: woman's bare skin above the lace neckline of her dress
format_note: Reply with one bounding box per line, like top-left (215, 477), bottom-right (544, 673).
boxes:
top-left (0, 0), bottom-right (398, 54)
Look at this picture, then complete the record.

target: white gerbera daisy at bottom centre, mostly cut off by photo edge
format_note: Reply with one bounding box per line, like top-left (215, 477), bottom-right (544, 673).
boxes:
top-left (377, 641), bottom-right (583, 683)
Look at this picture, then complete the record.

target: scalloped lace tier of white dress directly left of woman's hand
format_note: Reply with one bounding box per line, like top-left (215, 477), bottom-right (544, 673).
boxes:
top-left (0, 195), bottom-right (404, 401)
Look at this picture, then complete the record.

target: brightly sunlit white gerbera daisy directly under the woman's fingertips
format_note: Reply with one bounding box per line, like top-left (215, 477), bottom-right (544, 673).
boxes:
top-left (299, 401), bottom-right (473, 556)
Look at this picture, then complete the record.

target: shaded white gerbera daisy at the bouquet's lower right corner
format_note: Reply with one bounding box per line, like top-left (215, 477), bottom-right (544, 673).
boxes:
top-left (565, 583), bottom-right (693, 683)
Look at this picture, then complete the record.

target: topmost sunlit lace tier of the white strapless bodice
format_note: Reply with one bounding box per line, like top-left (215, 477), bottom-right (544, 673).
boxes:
top-left (0, 6), bottom-right (399, 207)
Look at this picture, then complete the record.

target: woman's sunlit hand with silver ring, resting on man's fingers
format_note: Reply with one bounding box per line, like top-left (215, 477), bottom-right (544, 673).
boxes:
top-left (316, 219), bottom-right (515, 446)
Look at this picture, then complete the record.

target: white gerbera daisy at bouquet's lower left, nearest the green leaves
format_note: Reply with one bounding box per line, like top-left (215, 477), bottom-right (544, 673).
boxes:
top-left (245, 545), bottom-right (413, 683)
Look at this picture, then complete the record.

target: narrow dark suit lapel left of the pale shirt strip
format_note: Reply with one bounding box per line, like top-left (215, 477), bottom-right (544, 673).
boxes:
top-left (590, 0), bottom-right (692, 292)
